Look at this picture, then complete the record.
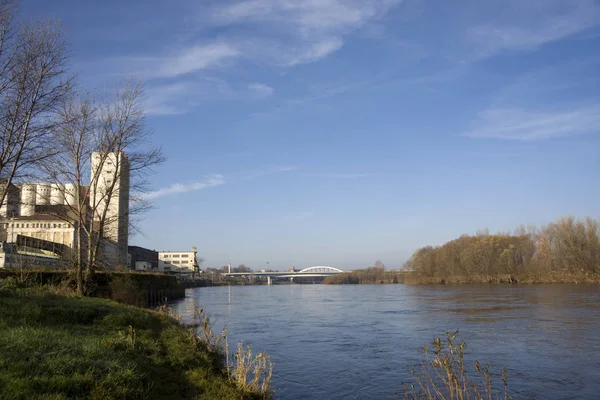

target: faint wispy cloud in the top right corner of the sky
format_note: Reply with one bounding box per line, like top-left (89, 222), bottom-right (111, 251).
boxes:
top-left (467, 0), bottom-right (600, 57)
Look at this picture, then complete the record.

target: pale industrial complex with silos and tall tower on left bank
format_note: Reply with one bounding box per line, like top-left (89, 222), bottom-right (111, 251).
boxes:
top-left (0, 152), bottom-right (130, 266)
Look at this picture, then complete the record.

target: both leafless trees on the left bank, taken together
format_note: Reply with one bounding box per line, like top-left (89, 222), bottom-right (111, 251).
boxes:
top-left (0, 0), bottom-right (163, 293)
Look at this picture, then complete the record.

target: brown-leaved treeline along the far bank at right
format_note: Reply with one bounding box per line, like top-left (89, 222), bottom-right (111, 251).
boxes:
top-left (405, 217), bottom-right (600, 283)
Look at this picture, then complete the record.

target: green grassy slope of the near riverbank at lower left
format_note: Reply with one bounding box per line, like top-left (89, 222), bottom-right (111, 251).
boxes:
top-left (0, 290), bottom-right (262, 399)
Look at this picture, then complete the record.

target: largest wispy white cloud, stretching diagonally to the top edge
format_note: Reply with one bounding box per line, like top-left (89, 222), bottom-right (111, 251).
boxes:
top-left (111, 0), bottom-right (401, 79)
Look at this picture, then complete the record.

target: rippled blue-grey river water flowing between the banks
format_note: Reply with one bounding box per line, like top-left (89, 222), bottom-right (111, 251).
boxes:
top-left (174, 285), bottom-right (600, 400)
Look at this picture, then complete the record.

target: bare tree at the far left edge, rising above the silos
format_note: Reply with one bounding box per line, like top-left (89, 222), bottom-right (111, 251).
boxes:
top-left (0, 0), bottom-right (72, 209)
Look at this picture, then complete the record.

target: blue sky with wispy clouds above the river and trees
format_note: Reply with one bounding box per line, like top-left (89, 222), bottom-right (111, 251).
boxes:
top-left (22, 0), bottom-right (600, 269)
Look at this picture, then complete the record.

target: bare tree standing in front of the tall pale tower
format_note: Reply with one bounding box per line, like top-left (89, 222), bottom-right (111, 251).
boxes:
top-left (46, 82), bottom-right (163, 293)
